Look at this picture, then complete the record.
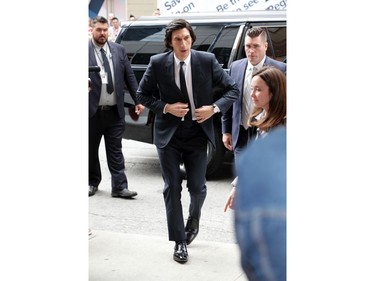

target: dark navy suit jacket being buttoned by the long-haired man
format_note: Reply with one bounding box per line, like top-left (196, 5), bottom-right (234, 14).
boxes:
top-left (137, 50), bottom-right (239, 148)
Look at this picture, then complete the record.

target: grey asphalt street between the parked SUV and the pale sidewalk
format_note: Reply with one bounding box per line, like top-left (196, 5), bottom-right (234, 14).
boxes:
top-left (89, 137), bottom-right (235, 243)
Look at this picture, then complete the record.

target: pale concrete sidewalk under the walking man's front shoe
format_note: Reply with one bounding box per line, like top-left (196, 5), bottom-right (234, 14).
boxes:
top-left (89, 230), bottom-right (247, 281)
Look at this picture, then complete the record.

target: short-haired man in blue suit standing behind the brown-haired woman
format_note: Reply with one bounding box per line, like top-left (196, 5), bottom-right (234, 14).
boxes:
top-left (222, 27), bottom-right (286, 158)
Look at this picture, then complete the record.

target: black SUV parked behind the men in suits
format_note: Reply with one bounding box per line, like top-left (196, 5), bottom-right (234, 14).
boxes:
top-left (116, 10), bottom-right (287, 177)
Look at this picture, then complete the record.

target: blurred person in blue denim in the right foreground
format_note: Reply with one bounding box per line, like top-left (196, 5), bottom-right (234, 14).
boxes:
top-left (234, 126), bottom-right (286, 281)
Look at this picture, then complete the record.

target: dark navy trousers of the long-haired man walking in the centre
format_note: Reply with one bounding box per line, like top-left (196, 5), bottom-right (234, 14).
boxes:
top-left (158, 122), bottom-right (207, 241)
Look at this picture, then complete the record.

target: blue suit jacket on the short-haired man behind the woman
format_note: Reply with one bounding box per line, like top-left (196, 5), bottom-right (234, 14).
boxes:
top-left (221, 56), bottom-right (286, 148)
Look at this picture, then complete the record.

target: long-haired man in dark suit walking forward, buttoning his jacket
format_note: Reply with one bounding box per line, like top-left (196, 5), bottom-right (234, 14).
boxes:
top-left (137, 19), bottom-right (239, 263)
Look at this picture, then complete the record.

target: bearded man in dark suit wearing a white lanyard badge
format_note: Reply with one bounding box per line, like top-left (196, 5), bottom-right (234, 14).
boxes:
top-left (89, 16), bottom-right (144, 198)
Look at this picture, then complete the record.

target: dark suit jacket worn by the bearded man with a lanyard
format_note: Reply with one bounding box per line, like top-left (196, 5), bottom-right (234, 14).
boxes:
top-left (89, 39), bottom-right (138, 118)
